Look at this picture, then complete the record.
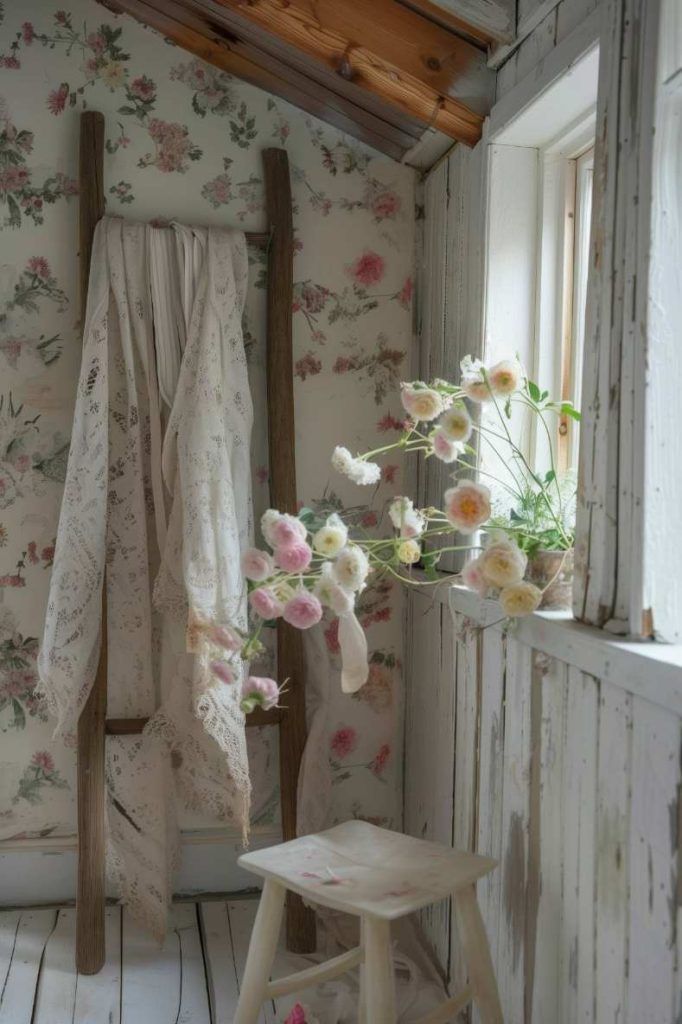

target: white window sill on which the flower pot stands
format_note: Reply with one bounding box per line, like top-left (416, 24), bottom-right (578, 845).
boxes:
top-left (438, 585), bottom-right (682, 716)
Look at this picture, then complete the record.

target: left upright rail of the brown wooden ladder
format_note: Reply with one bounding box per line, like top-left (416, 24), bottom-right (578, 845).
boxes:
top-left (76, 111), bottom-right (108, 974)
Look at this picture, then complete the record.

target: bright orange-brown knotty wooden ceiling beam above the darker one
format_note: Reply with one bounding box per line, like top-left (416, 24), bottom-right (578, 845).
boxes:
top-left (204, 0), bottom-right (489, 145)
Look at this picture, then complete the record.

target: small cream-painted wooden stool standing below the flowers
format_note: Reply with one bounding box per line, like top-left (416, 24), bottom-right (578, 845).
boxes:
top-left (235, 821), bottom-right (502, 1024)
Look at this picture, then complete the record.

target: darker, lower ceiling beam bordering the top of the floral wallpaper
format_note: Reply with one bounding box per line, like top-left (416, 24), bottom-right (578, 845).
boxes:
top-left (99, 0), bottom-right (426, 160)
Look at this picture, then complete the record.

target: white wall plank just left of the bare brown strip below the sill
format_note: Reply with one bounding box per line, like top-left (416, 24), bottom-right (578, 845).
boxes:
top-left (497, 636), bottom-right (531, 1024)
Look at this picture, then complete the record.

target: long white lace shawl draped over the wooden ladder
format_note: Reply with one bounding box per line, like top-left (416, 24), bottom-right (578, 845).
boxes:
top-left (39, 218), bottom-right (253, 936)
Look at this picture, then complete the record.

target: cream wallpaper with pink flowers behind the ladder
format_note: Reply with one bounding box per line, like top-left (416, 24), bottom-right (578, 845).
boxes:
top-left (0, 0), bottom-right (415, 838)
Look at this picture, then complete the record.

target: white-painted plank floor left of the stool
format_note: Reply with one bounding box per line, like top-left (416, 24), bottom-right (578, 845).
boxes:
top-left (0, 899), bottom-right (309, 1024)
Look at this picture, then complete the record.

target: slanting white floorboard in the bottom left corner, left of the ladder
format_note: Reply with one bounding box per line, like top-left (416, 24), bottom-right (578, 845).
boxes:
top-left (0, 910), bottom-right (57, 1024)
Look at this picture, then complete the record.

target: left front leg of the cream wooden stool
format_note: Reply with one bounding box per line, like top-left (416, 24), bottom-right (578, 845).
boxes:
top-left (233, 879), bottom-right (287, 1024)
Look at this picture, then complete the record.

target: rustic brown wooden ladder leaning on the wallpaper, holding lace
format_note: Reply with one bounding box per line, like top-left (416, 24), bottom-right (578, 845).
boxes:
top-left (76, 111), bottom-right (315, 974)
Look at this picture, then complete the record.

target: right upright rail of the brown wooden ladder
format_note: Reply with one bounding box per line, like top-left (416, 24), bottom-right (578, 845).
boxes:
top-left (263, 148), bottom-right (315, 952)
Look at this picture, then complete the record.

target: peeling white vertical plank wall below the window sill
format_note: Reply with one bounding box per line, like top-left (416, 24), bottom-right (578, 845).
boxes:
top-left (406, 593), bottom-right (682, 1024)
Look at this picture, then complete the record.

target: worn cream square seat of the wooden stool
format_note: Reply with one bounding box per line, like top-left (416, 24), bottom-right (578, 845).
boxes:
top-left (239, 821), bottom-right (497, 921)
